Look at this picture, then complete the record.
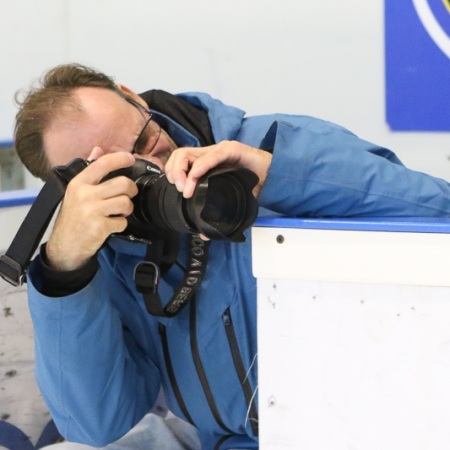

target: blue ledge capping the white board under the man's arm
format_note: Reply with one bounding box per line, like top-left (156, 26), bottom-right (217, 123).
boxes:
top-left (253, 217), bottom-right (450, 233)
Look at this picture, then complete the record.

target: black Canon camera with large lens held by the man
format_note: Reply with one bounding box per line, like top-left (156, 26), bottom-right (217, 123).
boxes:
top-left (54, 159), bottom-right (259, 242)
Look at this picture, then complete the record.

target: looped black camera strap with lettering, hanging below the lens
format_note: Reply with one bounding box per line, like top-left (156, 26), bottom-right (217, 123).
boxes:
top-left (134, 234), bottom-right (209, 317)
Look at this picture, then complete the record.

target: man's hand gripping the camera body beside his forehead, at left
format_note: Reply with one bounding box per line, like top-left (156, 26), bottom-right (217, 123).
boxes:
top-left (46, 148), bottom-right (138, 270)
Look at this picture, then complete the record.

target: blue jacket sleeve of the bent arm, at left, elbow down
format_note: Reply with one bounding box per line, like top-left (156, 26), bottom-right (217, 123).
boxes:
top-left (28, 253), bottom-right (160, 447)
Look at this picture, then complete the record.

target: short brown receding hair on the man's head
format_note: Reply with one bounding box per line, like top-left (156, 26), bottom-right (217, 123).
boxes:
top-left (14, 64), bottom-right (123, 181)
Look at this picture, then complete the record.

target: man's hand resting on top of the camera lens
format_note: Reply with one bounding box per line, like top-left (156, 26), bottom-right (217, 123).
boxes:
top-left (164, 141), bottom-right (272, 198)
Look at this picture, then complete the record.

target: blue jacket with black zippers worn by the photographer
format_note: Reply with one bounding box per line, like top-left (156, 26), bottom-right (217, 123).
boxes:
top-left (28, 93), bottom-right (450, 450)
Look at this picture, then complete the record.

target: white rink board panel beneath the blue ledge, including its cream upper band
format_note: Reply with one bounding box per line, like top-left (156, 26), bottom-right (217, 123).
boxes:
top-left (253, 221), bottom-right (450, 450)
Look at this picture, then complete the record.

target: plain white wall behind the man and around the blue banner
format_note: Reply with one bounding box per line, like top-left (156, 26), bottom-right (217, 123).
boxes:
top-left (0, 0), bottom-right (450, 185)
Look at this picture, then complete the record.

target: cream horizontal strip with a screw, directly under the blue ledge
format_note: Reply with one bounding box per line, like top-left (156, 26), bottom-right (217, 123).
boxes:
top-left (252, 227), bottom-right (450, 286)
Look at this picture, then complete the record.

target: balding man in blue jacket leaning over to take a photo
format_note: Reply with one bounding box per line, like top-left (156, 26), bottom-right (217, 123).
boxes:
top-left (15, 65), bottom-right (450, 450)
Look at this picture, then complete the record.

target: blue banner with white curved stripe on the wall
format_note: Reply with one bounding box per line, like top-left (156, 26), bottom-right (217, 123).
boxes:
top-left (385, 0), bottom-right (450, 131)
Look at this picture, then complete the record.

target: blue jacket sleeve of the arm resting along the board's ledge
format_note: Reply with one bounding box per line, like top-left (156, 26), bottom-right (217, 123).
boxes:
top-left (250, 116), bottom-right (450, 217)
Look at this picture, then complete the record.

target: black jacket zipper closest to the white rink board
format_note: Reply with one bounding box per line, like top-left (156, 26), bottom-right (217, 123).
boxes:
top-left (222, 308), bottom-right (258, 436)
